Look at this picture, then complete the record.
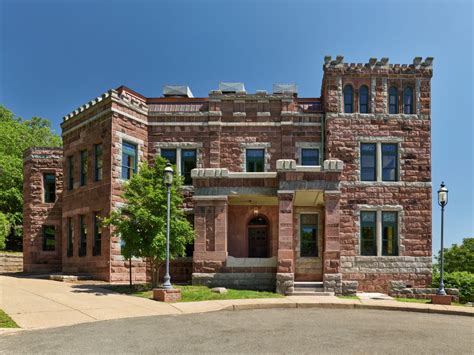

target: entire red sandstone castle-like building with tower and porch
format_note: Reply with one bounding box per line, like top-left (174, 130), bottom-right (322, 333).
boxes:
top-left (24, 57), bottom-right (432, 293)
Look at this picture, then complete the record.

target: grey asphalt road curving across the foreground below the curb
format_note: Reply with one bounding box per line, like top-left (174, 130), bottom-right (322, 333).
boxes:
top-left (0, 309), bottom-right (474, 354)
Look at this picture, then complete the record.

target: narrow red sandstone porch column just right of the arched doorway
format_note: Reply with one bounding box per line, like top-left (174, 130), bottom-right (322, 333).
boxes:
top-left (276, 191), bottom-right (295, 294)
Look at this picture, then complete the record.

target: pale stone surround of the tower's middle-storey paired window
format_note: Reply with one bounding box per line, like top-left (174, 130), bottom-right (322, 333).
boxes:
top-left (356, 137), bottom-right (403, 183)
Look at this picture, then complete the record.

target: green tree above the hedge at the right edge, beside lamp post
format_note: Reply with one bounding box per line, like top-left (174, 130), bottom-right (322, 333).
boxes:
top-left (436, 238), bottom-right (474, 273)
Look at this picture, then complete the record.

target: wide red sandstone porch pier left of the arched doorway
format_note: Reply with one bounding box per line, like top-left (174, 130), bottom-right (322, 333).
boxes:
top-left (193, 196), bottom-right (228, 284)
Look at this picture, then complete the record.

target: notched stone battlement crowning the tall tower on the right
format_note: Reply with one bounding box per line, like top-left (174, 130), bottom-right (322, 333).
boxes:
top-left (323, 55), bottom-right (434, 76)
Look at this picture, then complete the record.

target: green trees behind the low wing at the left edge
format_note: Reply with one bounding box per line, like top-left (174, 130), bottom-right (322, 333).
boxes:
top-left (0, 106), bottom-right (61, 247)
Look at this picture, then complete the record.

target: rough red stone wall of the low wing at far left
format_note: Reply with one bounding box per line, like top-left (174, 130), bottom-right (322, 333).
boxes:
top-left (23, 148), bottom-right (63, 272)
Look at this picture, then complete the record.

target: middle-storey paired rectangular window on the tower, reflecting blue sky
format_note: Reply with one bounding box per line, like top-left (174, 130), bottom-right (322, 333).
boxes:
top-left (360, 142), bottom-right (399, 181)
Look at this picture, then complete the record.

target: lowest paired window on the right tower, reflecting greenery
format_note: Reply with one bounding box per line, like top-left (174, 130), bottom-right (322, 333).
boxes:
top-left (360, 210), bottom-right (399, 256)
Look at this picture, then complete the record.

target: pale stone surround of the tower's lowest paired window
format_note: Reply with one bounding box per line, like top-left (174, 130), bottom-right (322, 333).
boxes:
top-left (355, 205), bottom-right (405, 258)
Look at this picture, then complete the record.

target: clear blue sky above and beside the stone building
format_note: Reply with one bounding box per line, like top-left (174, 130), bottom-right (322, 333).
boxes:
top-left (0, 0), bottom-right (474, 251)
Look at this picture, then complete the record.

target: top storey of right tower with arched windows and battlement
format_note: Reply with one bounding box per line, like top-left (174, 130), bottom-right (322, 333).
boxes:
top-left (321, 56), bottom-right (433, 118)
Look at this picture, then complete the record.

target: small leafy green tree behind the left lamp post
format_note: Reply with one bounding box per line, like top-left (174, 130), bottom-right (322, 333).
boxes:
top-left (104, 157), bottom-right (194, 286)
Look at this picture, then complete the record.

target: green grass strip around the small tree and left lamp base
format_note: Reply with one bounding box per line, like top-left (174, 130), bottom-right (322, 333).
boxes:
top-left (103, 284), bottom-right (284, 302)
